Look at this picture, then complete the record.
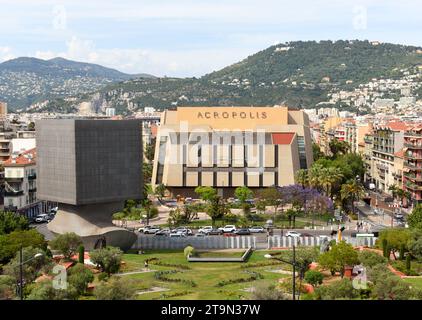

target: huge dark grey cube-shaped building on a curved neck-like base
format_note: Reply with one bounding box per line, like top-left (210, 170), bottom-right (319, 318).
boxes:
top-left (36, 119), bottom-right (142, 251)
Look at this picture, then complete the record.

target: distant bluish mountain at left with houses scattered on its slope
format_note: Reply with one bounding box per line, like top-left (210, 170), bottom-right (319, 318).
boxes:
top-left (0, 57), bottom-right (155, 110)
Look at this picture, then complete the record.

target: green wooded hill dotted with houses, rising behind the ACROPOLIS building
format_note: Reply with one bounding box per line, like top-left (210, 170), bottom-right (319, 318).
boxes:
top-left (23, 40), bottom-right (422, 114)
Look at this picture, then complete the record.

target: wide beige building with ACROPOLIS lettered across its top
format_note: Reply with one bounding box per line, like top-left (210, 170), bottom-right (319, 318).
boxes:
top-left (152, 106), bottom-right (313, 196)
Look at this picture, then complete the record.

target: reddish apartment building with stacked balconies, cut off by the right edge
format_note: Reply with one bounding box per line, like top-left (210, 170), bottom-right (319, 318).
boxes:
top-left (403, 125), bottom-right (422, 204)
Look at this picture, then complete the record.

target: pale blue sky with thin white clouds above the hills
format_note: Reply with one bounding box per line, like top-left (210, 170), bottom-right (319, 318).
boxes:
top-left (0, 0), bottom-right (422, 77)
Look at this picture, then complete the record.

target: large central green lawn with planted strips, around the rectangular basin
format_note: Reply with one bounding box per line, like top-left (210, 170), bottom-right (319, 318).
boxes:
top-left (122, 250), bottom-right (285, 300)
